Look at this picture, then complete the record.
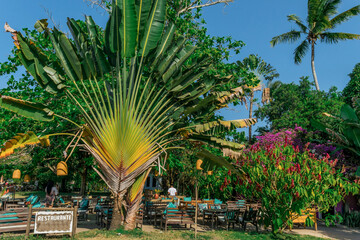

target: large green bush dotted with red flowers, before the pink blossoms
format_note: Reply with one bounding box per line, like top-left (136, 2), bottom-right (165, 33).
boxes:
top-left (236, 140), bottom-right (360, 232)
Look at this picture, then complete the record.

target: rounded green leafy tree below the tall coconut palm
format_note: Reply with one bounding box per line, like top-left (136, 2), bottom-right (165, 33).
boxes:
top-left (255, 77), bottom-right (343, 131)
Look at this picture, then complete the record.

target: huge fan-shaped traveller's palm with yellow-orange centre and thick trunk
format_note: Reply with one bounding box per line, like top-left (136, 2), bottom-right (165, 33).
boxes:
top-left (0, 0), bottom-right (256, 229)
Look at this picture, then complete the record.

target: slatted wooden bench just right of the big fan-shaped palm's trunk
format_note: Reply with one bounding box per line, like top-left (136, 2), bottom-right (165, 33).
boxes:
top-left (160, 208), bottom-right (195, 232)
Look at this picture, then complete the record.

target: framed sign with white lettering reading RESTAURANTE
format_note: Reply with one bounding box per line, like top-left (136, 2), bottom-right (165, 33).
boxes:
top-left (34, 211), bottom-right (74, 234)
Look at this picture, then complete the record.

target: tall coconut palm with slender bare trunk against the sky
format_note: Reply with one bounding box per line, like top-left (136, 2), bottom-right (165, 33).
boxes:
top-left (270, 0), bottom-right (360, 90)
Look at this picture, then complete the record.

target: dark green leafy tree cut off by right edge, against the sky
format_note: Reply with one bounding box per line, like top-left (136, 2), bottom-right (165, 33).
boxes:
top-left (342, 63), bottom-right (360, 105)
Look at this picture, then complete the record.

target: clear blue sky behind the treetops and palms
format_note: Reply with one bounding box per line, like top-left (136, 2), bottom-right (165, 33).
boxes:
top-left (0, 0), bottom-right (360, 131)
